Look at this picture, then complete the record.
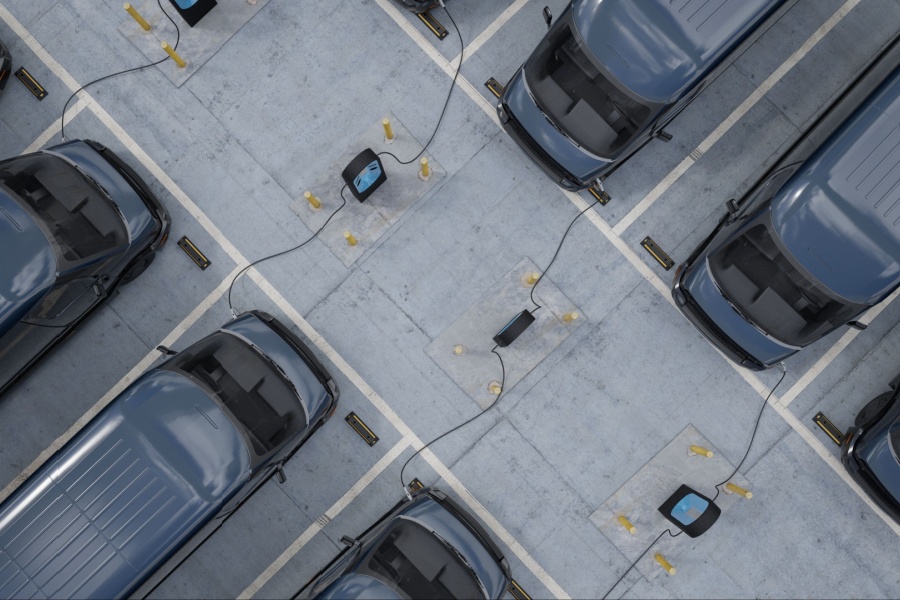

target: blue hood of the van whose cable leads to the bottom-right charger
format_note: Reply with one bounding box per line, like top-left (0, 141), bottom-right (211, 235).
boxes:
top-left (683, 260), bottom-right (798, 367)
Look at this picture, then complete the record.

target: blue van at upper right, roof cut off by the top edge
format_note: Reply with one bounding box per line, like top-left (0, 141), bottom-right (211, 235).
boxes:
top-left (497, 0), bottom-right (796, 190)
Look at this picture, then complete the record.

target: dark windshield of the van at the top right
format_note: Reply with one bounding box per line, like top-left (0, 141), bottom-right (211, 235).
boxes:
top-left (525, 11), bottom-right (661, 158)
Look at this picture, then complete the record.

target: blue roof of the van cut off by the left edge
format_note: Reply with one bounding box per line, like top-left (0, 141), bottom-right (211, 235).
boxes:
top-left (0, 189), bottom-right (57, 335)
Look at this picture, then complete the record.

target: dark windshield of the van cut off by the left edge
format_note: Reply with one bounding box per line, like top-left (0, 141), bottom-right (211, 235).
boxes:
top-left (0, 154), bottom-right (128, 262)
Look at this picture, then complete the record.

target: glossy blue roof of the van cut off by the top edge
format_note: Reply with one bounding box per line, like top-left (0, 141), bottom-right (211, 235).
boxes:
top-left (573, 0), bottom-right (783, 103)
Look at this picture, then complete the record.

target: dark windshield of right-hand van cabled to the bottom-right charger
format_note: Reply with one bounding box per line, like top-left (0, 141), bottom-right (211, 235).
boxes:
top-left (709, 210), bottom-right (866, 346)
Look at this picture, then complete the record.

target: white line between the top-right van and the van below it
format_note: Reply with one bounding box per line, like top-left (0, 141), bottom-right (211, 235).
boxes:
top-left (613, 0), bottom-right (859, 235)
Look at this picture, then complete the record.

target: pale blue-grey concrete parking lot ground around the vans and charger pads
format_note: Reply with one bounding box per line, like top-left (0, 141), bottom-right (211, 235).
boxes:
top-left (0, 0), bottom-right (900, 598)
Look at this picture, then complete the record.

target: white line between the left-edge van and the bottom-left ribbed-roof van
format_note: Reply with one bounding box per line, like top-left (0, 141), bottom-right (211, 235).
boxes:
top-left (0, 268), bottom-right (240, 502)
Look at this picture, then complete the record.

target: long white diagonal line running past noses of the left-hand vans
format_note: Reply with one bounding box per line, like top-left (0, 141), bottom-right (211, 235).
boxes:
top-left (0, 7), bottom-right (568, 598)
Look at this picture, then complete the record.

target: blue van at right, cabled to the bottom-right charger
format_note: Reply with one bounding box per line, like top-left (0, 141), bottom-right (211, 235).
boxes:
top-left (672, 37), bottom-right (900, 370)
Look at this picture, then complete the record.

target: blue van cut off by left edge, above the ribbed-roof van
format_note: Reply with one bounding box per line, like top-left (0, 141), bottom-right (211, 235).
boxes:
top-left (0, 140), bottom-right (171, 394)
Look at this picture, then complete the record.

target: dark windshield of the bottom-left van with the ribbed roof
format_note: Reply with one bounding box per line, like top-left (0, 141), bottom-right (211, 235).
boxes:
top-left (164, 332), bottom-right (306, 455)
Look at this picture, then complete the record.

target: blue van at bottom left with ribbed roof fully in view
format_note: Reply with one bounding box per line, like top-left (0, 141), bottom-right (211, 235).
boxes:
top-left (0, 311), bottom-right (338, 598)
